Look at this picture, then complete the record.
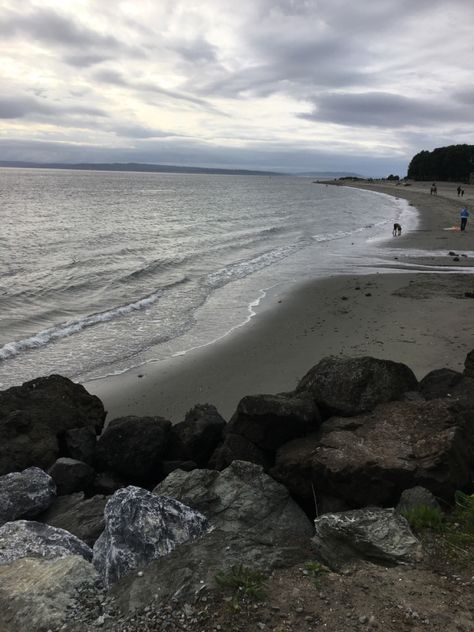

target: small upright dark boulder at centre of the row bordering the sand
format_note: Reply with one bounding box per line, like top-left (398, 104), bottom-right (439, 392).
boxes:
top-left (166, 404), bottom-right (226, 467)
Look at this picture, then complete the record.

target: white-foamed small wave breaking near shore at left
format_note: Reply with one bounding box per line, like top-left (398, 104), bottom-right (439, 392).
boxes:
top-left (0, 277), bottom-right (189, 361)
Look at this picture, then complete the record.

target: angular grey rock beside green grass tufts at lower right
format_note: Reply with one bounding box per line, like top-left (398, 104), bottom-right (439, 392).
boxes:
top-left (312, 507), bottom-right (421, 570)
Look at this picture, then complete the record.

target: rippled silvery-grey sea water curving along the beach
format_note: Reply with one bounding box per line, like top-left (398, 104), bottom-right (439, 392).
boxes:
top-left (0, 169), bottom-right (413, 388)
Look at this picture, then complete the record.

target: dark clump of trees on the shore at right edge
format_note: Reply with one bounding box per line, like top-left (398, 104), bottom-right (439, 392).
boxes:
top-left (407, 145), bottom-right (474, 183)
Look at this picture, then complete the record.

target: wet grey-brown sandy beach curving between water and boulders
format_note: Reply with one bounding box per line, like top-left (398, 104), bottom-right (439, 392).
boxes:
top-left (85, 182), bottom-right (474, 422)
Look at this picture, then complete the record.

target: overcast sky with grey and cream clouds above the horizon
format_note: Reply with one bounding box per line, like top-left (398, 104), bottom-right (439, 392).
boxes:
top-left (0, 0), bottom-right (474, 176)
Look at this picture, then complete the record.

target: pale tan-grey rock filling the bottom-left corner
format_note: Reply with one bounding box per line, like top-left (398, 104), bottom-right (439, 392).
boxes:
top-left (0, 555), bottom-right (97, 632)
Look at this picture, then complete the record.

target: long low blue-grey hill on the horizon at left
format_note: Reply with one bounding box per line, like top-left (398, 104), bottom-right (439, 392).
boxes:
top-left (0, 160), bottom-right (285, 176)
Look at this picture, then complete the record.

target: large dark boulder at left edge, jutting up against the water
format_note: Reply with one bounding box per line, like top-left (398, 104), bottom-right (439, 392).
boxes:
top-left (0, 375), bottom-right (105, 474)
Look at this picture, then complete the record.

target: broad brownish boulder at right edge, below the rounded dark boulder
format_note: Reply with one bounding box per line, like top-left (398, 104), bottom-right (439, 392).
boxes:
top-left (271, 399), bottom-right (474, 508)
